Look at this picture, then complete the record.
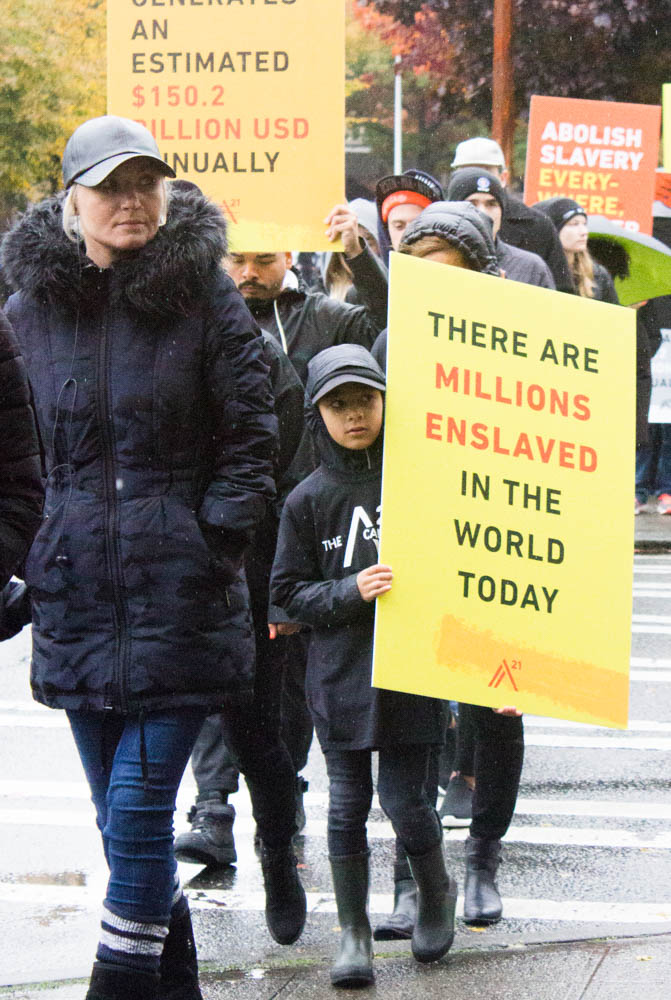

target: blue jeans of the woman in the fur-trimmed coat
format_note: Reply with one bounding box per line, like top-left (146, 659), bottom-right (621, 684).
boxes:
top-left (67, 707), bottom-right (206, 926)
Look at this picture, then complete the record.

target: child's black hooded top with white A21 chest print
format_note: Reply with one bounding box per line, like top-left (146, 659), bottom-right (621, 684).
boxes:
top-left (270, 352), bottom-right (443, 750)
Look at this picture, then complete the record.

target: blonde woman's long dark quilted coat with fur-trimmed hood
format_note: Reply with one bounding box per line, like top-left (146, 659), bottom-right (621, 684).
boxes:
top-left (3, 182), bottom-right (276, 712)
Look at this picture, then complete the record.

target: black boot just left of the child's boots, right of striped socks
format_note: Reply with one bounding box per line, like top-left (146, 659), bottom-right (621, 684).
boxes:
top-left (261, 843), bottom-right (307, 944)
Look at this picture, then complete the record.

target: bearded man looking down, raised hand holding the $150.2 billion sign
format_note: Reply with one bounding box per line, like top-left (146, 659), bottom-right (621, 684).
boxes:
top-left (176, 227), bottom-right (394, 865)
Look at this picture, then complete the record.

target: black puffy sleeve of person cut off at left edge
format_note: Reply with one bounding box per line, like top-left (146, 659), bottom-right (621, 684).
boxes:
top-left (0, 313), bottom-right (42, 589)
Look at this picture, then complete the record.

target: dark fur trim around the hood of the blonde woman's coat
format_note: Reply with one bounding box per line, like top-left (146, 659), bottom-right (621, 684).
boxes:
top-left (1, 185), bottom-right (227, 320)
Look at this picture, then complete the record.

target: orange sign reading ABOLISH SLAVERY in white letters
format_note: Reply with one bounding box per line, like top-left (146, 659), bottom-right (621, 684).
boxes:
top-left (524, 96), bottom-right (661, 233)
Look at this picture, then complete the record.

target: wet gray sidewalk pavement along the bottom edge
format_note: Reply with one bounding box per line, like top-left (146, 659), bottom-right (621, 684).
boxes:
top-left (0, 932), bottom-right (671, 1000)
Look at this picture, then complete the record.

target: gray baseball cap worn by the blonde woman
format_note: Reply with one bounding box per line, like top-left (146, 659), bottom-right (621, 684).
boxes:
top-left (63, 115), bottom-right (176, 188)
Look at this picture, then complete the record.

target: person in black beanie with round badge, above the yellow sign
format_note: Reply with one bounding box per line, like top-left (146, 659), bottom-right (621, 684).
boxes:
top-left (447, 167), bottom-right (555, 289)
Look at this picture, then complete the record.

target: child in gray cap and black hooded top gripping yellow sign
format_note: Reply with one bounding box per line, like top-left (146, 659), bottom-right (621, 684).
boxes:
top-left (271, 344), bottom-right (456, 987)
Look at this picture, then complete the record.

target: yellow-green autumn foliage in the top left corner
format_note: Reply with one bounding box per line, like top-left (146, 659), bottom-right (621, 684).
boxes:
top-left (0, 0), bottom-right (106, 229)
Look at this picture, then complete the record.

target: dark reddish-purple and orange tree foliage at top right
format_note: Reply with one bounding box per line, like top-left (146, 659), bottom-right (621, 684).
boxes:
top-left (356, 0), bottom-right (671, 115)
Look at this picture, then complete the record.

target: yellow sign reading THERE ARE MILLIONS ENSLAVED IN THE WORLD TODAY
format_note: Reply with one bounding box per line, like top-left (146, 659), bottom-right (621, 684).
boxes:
top-left (373, 254), bottom-right (635, 727)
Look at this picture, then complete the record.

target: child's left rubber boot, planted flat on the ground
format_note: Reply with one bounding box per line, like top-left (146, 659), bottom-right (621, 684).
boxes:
top-left (330, 853), bottom-right (374, 989)
